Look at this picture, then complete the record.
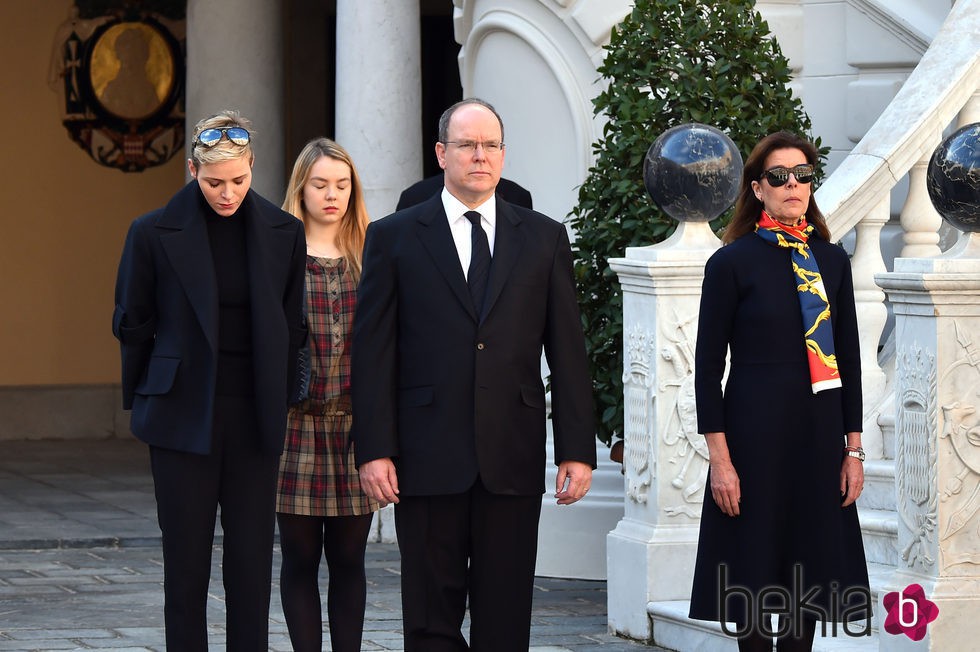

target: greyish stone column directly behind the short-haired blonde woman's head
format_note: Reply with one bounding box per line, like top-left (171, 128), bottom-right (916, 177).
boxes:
top-left (186, 0), bottom-right (286, 204)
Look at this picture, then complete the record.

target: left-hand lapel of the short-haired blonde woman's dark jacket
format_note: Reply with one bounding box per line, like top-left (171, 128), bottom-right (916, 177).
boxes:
top-left (157, 181), bottom-right (218, 352)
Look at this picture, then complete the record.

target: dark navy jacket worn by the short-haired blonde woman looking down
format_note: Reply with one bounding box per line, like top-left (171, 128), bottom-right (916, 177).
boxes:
top-left (112, 181), bottom-right (306, 454)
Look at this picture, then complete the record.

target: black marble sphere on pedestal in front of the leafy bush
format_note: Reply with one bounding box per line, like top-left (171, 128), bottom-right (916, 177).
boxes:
top-left (643, 123), bottom-right (742, 222)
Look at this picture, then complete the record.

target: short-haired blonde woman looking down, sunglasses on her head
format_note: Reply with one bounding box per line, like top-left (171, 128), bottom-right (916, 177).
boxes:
top-left (112, 111), bottom-right (306, 652)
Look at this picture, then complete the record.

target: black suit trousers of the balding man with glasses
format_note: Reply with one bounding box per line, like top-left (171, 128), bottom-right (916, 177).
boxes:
top-left (395, 479), bottom-right (541, 652)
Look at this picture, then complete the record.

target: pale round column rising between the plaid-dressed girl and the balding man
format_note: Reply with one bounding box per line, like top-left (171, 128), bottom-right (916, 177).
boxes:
top-left (335, 0), bottom-right (422, 219)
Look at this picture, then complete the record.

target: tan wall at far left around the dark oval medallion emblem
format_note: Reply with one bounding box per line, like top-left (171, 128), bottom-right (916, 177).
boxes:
top-left (0, 0), bottom-right (184, 388)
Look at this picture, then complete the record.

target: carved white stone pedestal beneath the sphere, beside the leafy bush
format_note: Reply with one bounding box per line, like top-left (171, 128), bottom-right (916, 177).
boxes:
top-left (606, 222), bottom-right (721, 640)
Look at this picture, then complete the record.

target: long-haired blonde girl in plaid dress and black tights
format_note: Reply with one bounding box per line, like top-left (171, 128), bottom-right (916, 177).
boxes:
top-left (276, 138), bottom-right (379, 652)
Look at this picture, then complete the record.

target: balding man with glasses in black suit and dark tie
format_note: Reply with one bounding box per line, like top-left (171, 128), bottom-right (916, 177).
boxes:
top-left (352, 99), bottom-right (595, 652)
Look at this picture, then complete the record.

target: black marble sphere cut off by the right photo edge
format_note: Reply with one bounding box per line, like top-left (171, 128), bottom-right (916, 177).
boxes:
top-left (926, 122), bottom-right (980, 233)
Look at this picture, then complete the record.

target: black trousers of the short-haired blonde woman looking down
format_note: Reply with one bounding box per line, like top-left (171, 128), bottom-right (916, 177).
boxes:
top-left (150, 396), bottom-right (279, 652)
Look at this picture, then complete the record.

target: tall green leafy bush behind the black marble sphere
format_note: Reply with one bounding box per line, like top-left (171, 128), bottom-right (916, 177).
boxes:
top-left (570, 0), bottom-right (820, 444)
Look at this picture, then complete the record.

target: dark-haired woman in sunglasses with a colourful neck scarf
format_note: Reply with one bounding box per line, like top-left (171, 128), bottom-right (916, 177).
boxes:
top-left (690, 132), bottom-right (871, 652)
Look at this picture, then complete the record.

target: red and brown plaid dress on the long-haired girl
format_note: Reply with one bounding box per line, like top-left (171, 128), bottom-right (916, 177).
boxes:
top-left (276, 256), bottom-right (379, 516)
